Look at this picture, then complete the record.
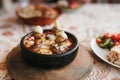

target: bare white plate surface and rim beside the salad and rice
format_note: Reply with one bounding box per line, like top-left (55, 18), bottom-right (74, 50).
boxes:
top-left (91, 39), bottom-right (120, 68)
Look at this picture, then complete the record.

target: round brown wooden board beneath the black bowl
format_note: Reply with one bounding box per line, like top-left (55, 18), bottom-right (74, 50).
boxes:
top-left (7, 46), bottom-right (93, 80)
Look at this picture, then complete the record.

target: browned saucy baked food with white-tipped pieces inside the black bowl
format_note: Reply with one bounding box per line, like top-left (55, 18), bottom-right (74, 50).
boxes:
top-left (24, 21), bottom-right (73, 55)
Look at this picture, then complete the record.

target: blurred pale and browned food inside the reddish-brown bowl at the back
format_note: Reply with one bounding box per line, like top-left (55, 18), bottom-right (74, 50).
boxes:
top-left (18, 4), bottom-right (58, 18)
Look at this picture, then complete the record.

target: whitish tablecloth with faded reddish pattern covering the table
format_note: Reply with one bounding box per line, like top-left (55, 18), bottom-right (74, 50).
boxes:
top-left (0, 4), bottom-right (120, 80)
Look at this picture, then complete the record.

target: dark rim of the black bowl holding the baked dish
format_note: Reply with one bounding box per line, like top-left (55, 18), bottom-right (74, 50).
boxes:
top-left (20, 29), bottom-right (79, 57)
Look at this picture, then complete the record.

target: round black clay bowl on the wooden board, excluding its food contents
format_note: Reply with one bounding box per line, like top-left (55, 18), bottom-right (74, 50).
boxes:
top-left (20, 30), bottom-right (79, 68)
